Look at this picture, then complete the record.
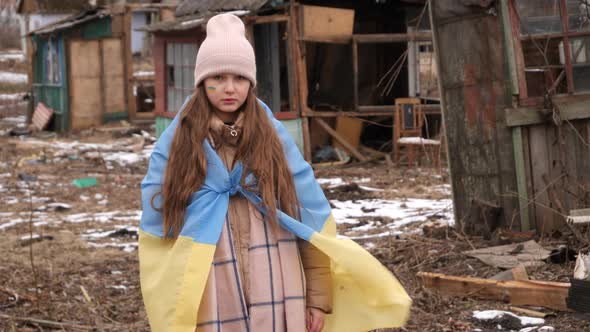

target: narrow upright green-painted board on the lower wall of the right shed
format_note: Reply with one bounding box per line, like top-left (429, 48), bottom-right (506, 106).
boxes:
top-left (512, 127), bottom-right (531, 232)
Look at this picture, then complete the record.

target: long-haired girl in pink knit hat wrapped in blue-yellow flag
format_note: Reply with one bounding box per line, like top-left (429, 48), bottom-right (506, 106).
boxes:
top-left (139, 14), bottom-right (410, 332)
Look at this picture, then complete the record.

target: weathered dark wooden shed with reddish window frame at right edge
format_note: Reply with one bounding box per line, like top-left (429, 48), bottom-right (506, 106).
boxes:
top-left (431, 0), bottom-right (590, 234)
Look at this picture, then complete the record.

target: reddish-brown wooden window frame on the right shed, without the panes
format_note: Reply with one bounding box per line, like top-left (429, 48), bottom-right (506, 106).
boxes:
top-left (508, 0), bottom-right (590, 106)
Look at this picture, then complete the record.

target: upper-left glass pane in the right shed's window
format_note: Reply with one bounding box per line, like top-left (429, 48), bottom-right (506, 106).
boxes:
top-left (516, 0), bottom-right (562, 35)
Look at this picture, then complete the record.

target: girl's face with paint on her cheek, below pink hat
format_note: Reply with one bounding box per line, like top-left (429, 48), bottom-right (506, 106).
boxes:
top-left (204, 74), bottom-right (250, 121)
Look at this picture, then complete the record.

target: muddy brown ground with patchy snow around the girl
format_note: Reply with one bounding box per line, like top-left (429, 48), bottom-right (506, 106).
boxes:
top-left (0, 118), bottom-right (590, 331)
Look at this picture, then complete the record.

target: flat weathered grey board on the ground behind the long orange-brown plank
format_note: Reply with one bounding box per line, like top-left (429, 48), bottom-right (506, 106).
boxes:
top-left (463, 240), bottom-right (551, 269)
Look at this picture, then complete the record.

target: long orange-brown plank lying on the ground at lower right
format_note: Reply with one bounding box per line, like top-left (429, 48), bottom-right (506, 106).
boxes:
top-left (418, 272), bottom-right (570, 311)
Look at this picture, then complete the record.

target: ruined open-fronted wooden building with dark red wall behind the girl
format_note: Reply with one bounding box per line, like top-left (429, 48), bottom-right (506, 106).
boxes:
top-left (146, 0), bottom-right (441, 160)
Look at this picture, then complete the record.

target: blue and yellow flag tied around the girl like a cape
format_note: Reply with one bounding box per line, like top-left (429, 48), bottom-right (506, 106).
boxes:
top-left (139, 102), bottom-right (411, 332)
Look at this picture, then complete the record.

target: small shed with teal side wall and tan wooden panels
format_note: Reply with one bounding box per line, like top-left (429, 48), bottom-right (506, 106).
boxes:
top-left (30, 8), bottom-right (134, 131)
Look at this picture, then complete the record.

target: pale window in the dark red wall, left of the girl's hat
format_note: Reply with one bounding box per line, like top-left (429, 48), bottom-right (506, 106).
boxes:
top-left (166, 43), bottom-right (197, 112)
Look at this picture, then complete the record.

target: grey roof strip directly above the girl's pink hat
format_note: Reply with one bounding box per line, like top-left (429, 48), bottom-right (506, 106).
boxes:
top-left (176, 0), bottom-right (269, 17)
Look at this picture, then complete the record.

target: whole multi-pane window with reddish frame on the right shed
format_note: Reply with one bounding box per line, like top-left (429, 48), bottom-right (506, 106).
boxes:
top-left (510, 0), bottom-right (590, 98)
